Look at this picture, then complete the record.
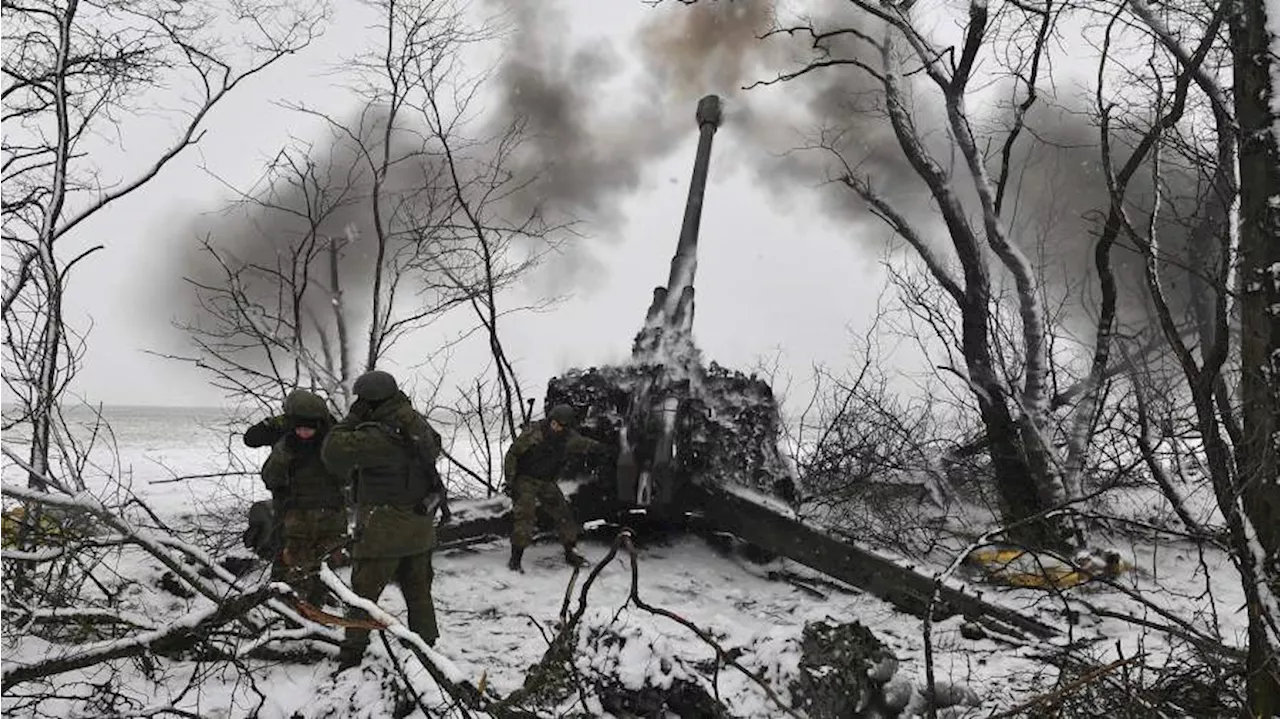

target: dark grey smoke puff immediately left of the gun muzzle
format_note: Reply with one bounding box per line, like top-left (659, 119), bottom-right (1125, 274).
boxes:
top-left (478, 0), bottom-right (756, 285)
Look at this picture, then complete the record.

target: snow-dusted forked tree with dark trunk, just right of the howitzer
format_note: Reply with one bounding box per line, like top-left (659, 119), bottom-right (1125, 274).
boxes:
top-left (737, 1), bottom-right (1079, 546)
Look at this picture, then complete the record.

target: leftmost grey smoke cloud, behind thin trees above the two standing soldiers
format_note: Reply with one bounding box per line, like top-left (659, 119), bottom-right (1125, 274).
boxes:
top-left (152, 106), bottom-right (438, 378)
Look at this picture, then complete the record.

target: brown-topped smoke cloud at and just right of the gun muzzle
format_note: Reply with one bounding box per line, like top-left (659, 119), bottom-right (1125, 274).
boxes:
top-left (629, 0), bottom-right (940, 236)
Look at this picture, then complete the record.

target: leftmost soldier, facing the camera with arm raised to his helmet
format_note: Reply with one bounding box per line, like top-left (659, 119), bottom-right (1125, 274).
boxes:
top-left (244, 389), bottom-right (347, 605)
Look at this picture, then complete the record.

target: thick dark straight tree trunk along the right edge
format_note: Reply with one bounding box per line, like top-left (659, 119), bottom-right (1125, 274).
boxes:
top-left (1231, 0), bottom-right (1280, 716)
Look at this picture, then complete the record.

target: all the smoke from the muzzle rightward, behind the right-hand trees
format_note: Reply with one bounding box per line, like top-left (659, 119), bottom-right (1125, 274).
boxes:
top-left (640, 0), bottom-right (1212, 330)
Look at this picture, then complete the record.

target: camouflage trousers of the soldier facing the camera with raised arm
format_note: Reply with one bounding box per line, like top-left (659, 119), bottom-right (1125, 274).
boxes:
top-left (279, 509), bottom-right (347, 605)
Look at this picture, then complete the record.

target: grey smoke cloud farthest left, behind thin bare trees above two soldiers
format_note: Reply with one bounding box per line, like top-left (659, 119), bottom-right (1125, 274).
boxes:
top-left (152, 105), bottom-right (442, 381)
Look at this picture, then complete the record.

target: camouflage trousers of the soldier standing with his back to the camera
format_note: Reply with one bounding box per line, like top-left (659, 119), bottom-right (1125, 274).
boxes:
top-left (340, 550), bottom-right (440, 659)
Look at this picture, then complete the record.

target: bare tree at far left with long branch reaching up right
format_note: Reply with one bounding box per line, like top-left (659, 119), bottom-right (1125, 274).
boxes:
top-left (0, 0), bottom-right (325, 487)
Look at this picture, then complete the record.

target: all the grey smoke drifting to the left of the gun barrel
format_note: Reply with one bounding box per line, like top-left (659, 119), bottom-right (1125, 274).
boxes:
top-left (151, 0), bottom-right (736, 378)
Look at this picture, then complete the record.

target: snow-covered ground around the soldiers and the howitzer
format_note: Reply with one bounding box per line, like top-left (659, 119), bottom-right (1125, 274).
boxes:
top-left (0, 413), bottom-right (1244, 719)
